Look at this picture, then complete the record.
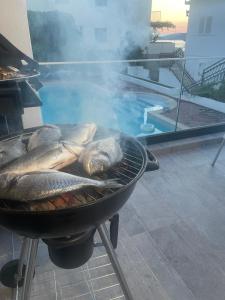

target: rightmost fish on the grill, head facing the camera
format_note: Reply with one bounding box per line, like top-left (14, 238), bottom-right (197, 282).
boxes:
top-left (79, 137), bottom-right (123, 175)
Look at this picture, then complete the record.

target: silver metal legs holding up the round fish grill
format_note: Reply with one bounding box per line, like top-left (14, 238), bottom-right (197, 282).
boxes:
top-left (8, 224), bottom-right (134, 300)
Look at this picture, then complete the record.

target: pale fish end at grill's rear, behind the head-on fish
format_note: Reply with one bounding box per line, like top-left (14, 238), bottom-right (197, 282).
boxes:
top-left (63, 123), bottom-right (97, 145)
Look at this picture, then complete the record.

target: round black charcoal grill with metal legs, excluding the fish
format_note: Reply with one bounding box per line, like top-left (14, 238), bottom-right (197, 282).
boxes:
top-left (0, 127), bottom-right (159, 300)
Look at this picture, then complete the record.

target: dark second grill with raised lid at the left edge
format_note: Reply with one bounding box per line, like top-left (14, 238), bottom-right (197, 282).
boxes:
top-left (0, 34), bottom-right (42, 136)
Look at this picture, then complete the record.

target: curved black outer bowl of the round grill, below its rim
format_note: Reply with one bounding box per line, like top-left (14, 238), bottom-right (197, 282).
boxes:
top-left (0, 183), bottom-right (135, 239)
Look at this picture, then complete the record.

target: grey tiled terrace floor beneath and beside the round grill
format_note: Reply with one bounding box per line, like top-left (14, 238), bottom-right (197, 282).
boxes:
top-left (0, 141), bottom-right (225, 300)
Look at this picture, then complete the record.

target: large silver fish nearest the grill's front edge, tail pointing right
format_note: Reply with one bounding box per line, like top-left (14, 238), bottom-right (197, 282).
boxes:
top-left (0, 170), bottom-right (122, 202)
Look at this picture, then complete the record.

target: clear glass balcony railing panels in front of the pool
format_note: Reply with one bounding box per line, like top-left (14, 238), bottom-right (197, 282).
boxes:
top-left (35, 58), bottom-right (225, 136)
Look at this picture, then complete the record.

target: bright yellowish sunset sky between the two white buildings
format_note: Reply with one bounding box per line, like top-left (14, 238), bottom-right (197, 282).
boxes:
top-left (152, 0), bottom-right (189, 33)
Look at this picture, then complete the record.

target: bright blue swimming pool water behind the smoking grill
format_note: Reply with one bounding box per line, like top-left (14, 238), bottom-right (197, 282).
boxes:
top-left (40, 84), bottom-right (173, 136)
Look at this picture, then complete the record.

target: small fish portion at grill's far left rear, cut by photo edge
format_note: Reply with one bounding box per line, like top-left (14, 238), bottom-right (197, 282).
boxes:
top-left (0, 136), bottom-right (26, 167)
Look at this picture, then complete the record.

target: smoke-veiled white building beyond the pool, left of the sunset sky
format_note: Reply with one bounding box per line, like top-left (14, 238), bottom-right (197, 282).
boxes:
top-left (28, 0), bottom-right (152, 60)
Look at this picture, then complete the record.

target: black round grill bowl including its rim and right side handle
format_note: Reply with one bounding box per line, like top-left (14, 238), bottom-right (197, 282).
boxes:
top-left (0, 136), bottom-right (158, 239)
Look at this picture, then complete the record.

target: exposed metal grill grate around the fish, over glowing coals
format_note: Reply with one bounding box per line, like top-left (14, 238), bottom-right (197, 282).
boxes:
top-left (0, 138), bottom-right (144, 211)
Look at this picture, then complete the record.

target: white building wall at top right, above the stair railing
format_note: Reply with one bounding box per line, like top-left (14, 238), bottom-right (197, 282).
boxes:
top-left (185, 0), bottom-right (225, 80)
